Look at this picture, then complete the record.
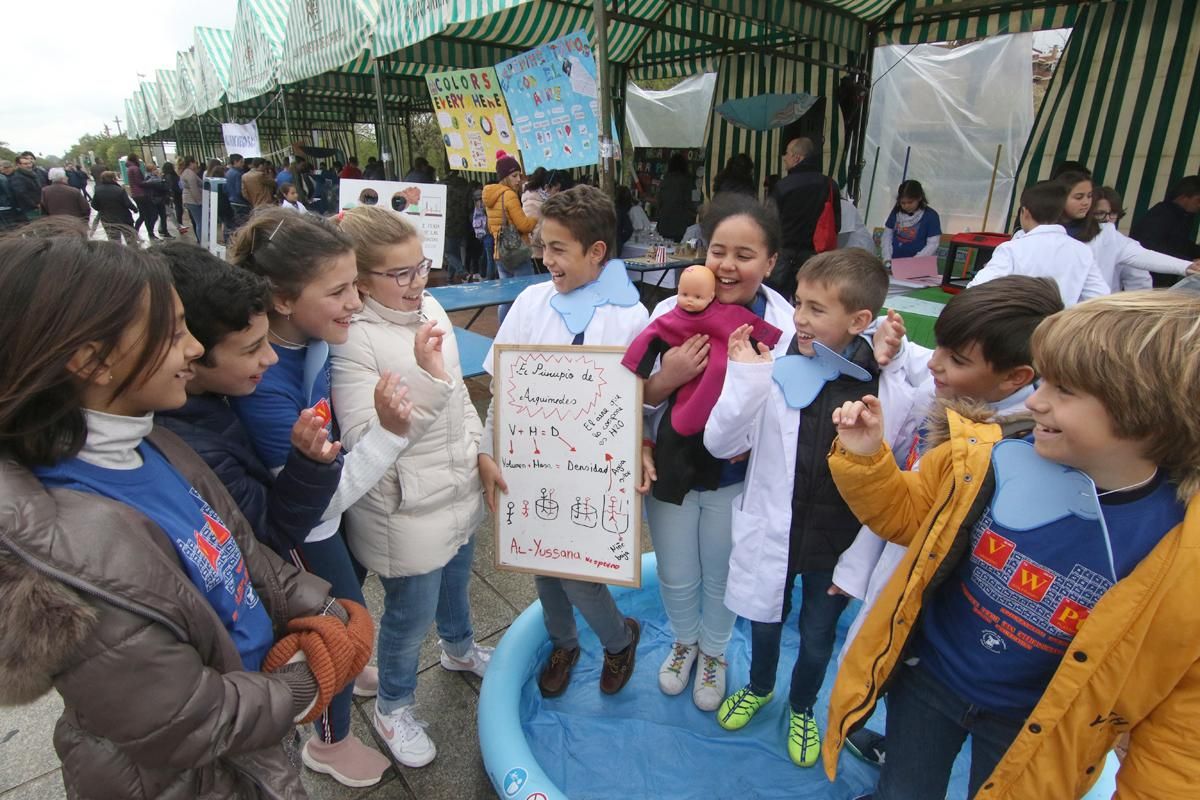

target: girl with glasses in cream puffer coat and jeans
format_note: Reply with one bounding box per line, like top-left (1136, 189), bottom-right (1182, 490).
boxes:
top-left (332, 206), bottom-right (492, 766)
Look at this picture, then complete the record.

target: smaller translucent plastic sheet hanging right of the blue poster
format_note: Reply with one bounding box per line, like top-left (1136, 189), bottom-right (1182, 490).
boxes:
top-left (625, 72), bottom-right (716, 148)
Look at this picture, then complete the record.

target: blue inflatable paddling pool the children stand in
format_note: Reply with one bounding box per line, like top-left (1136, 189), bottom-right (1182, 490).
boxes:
top-left (480, 554), bottom-right (1116, 800)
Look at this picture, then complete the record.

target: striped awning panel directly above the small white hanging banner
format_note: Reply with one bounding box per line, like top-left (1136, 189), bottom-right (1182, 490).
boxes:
top-left (228, 0), bottom-right (294, 102)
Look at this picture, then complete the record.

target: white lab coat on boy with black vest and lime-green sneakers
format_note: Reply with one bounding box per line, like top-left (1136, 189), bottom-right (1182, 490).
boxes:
top-left (704, 345), bottom-right (917, 622)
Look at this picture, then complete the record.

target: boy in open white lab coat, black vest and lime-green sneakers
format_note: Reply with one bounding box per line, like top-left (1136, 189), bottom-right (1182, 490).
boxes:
top-left (704, 248), bottom-right (916, 766)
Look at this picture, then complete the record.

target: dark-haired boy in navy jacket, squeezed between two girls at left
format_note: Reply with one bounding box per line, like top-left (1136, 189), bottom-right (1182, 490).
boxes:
top-left (155, 242), bottom-right (342, 558)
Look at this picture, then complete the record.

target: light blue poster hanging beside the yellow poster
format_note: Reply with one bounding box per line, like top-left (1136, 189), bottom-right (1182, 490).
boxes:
top-left (496, 30), bottom-right (616, 172)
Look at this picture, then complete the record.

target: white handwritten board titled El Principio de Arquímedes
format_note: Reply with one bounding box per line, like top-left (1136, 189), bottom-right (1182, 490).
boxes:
top-left (492, 344), bottom-right (642, 587)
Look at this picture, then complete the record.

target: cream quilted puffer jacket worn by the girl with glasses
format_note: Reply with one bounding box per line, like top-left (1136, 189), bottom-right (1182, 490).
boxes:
top-left (332, 294), bottom-right (484, 578)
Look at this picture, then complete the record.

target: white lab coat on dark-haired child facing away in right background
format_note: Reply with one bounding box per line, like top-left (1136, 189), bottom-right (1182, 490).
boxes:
top-left (967, 225), bottom-right (1112, 308)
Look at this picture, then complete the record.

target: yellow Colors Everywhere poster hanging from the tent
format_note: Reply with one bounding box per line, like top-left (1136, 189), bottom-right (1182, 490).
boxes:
top-left (425, 67), bottom-right (516, 172)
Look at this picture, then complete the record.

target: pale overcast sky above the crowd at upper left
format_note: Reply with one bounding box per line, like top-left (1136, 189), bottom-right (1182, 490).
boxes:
top-left (7, 0), bottom-right (238, 155)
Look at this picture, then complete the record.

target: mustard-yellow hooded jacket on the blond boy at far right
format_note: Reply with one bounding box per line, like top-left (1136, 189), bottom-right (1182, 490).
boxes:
top-left (823, 411), bottom-right (1200, 800)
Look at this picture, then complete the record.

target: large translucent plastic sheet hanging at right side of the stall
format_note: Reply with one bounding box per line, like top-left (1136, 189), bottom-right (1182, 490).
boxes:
top-left (858, 34), bottom-right (1033, 233)
